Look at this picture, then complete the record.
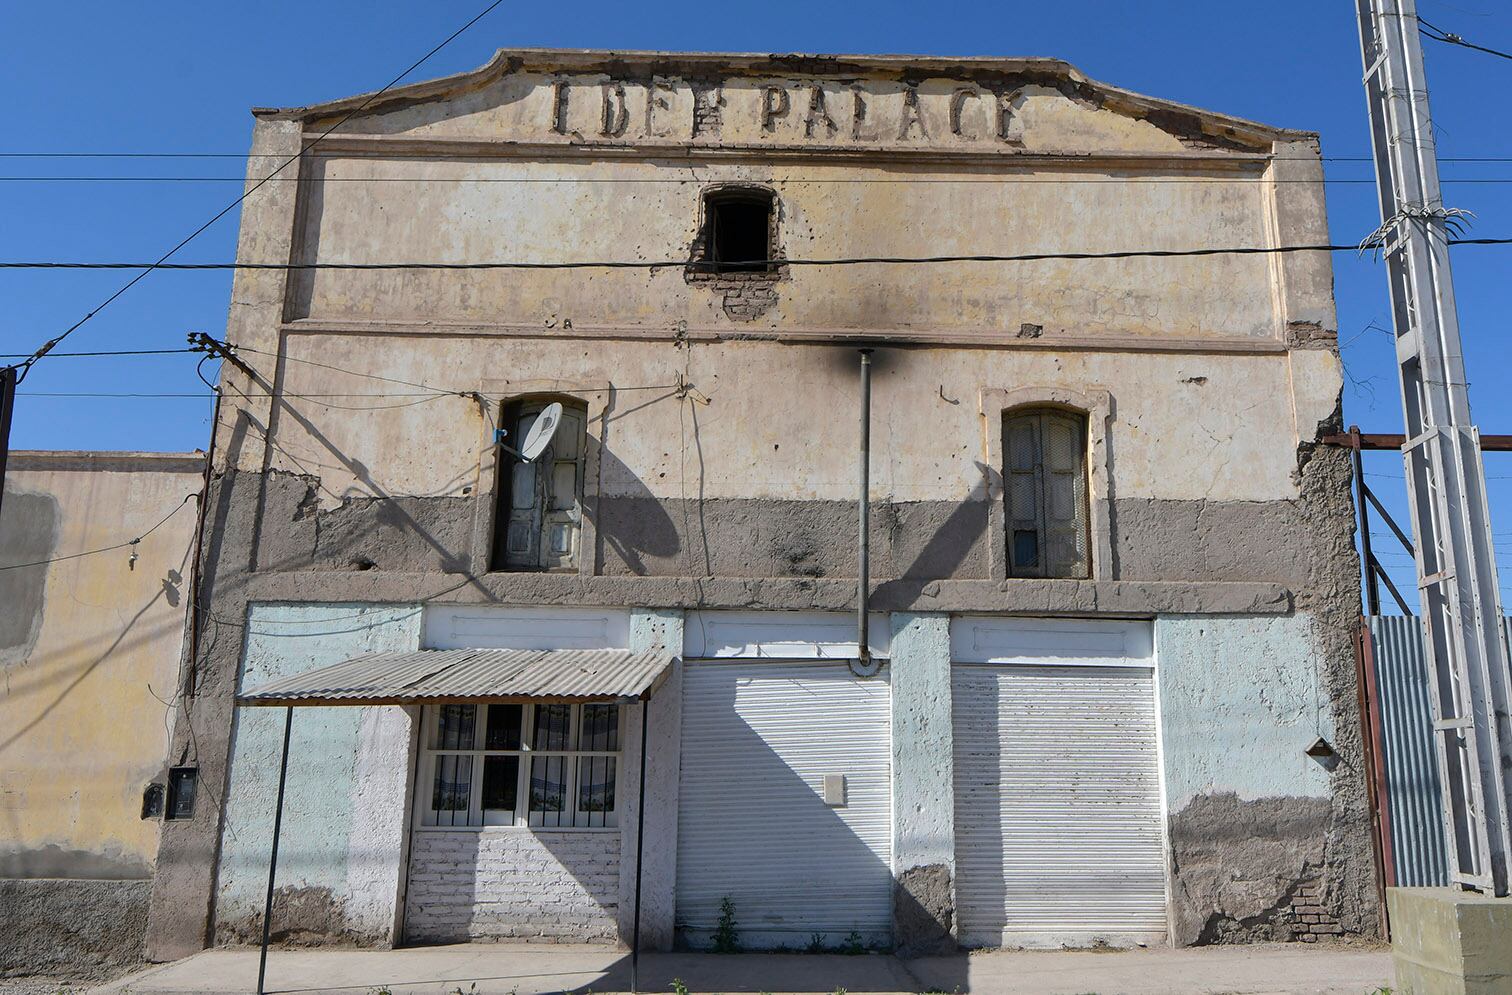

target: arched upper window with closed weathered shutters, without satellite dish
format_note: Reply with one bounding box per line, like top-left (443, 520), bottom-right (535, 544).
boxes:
top-left (1002, 408), bottom-right (1092, 578)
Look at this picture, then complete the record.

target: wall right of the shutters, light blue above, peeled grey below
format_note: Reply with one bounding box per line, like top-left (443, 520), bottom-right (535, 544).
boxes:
top-left (1155, 614), bottom-right (1334, 945)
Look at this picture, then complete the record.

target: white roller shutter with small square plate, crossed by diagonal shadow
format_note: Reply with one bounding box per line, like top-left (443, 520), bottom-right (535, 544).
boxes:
top-left (677, 659), bottom-right (892, 948)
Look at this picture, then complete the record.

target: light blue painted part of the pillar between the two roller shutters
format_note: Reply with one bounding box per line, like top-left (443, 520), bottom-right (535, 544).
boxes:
top-left (888, 612), bottom-right (956, 873)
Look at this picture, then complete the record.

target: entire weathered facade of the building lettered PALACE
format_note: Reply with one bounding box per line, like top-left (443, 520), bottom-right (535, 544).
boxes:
top-left (139, 51), bottom-right (1377, 959)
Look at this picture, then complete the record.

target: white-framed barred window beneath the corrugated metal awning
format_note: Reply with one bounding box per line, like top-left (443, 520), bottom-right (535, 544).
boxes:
top-left (414, 705), bottom-right (620, 829)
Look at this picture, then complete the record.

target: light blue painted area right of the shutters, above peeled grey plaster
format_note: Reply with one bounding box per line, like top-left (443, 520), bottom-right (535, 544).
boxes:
top-left (1155, 612), bottom-right (1334, 812)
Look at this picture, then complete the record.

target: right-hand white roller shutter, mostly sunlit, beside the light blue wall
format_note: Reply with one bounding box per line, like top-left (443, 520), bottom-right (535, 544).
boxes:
top-left (953, 664), bottom-right (1166, 947)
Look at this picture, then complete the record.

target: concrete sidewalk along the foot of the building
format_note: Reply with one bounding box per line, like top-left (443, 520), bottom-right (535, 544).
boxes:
top-left (95, 944), bottom-right (1391, 995)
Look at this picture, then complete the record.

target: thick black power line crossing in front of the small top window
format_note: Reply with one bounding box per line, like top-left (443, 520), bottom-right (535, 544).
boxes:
top-left (0, 237), bottom-right (1512, 267)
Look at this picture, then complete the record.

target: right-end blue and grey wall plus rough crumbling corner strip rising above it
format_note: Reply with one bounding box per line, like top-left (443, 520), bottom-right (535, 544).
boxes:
top-left (1157, 435), bottom-right (1380, 944)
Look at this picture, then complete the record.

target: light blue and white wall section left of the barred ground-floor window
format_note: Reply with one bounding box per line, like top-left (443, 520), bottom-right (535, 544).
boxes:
top-left (216, 605), bottom-right (422, 942)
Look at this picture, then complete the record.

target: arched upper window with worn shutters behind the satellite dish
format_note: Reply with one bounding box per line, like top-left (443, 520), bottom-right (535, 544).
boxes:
top-left (493, 398), bottom-right (588, 570)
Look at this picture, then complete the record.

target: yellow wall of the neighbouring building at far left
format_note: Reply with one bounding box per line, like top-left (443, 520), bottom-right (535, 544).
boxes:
top-left (0, 452), bottom-right (203, 879)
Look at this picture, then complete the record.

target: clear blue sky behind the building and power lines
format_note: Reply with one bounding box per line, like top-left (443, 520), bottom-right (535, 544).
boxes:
top-left (0, 0), bottom-right (1512, 600)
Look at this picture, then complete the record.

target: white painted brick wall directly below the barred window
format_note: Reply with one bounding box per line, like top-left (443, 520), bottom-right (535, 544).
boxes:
top-left (404, 830), bottom-right (620, 944)
